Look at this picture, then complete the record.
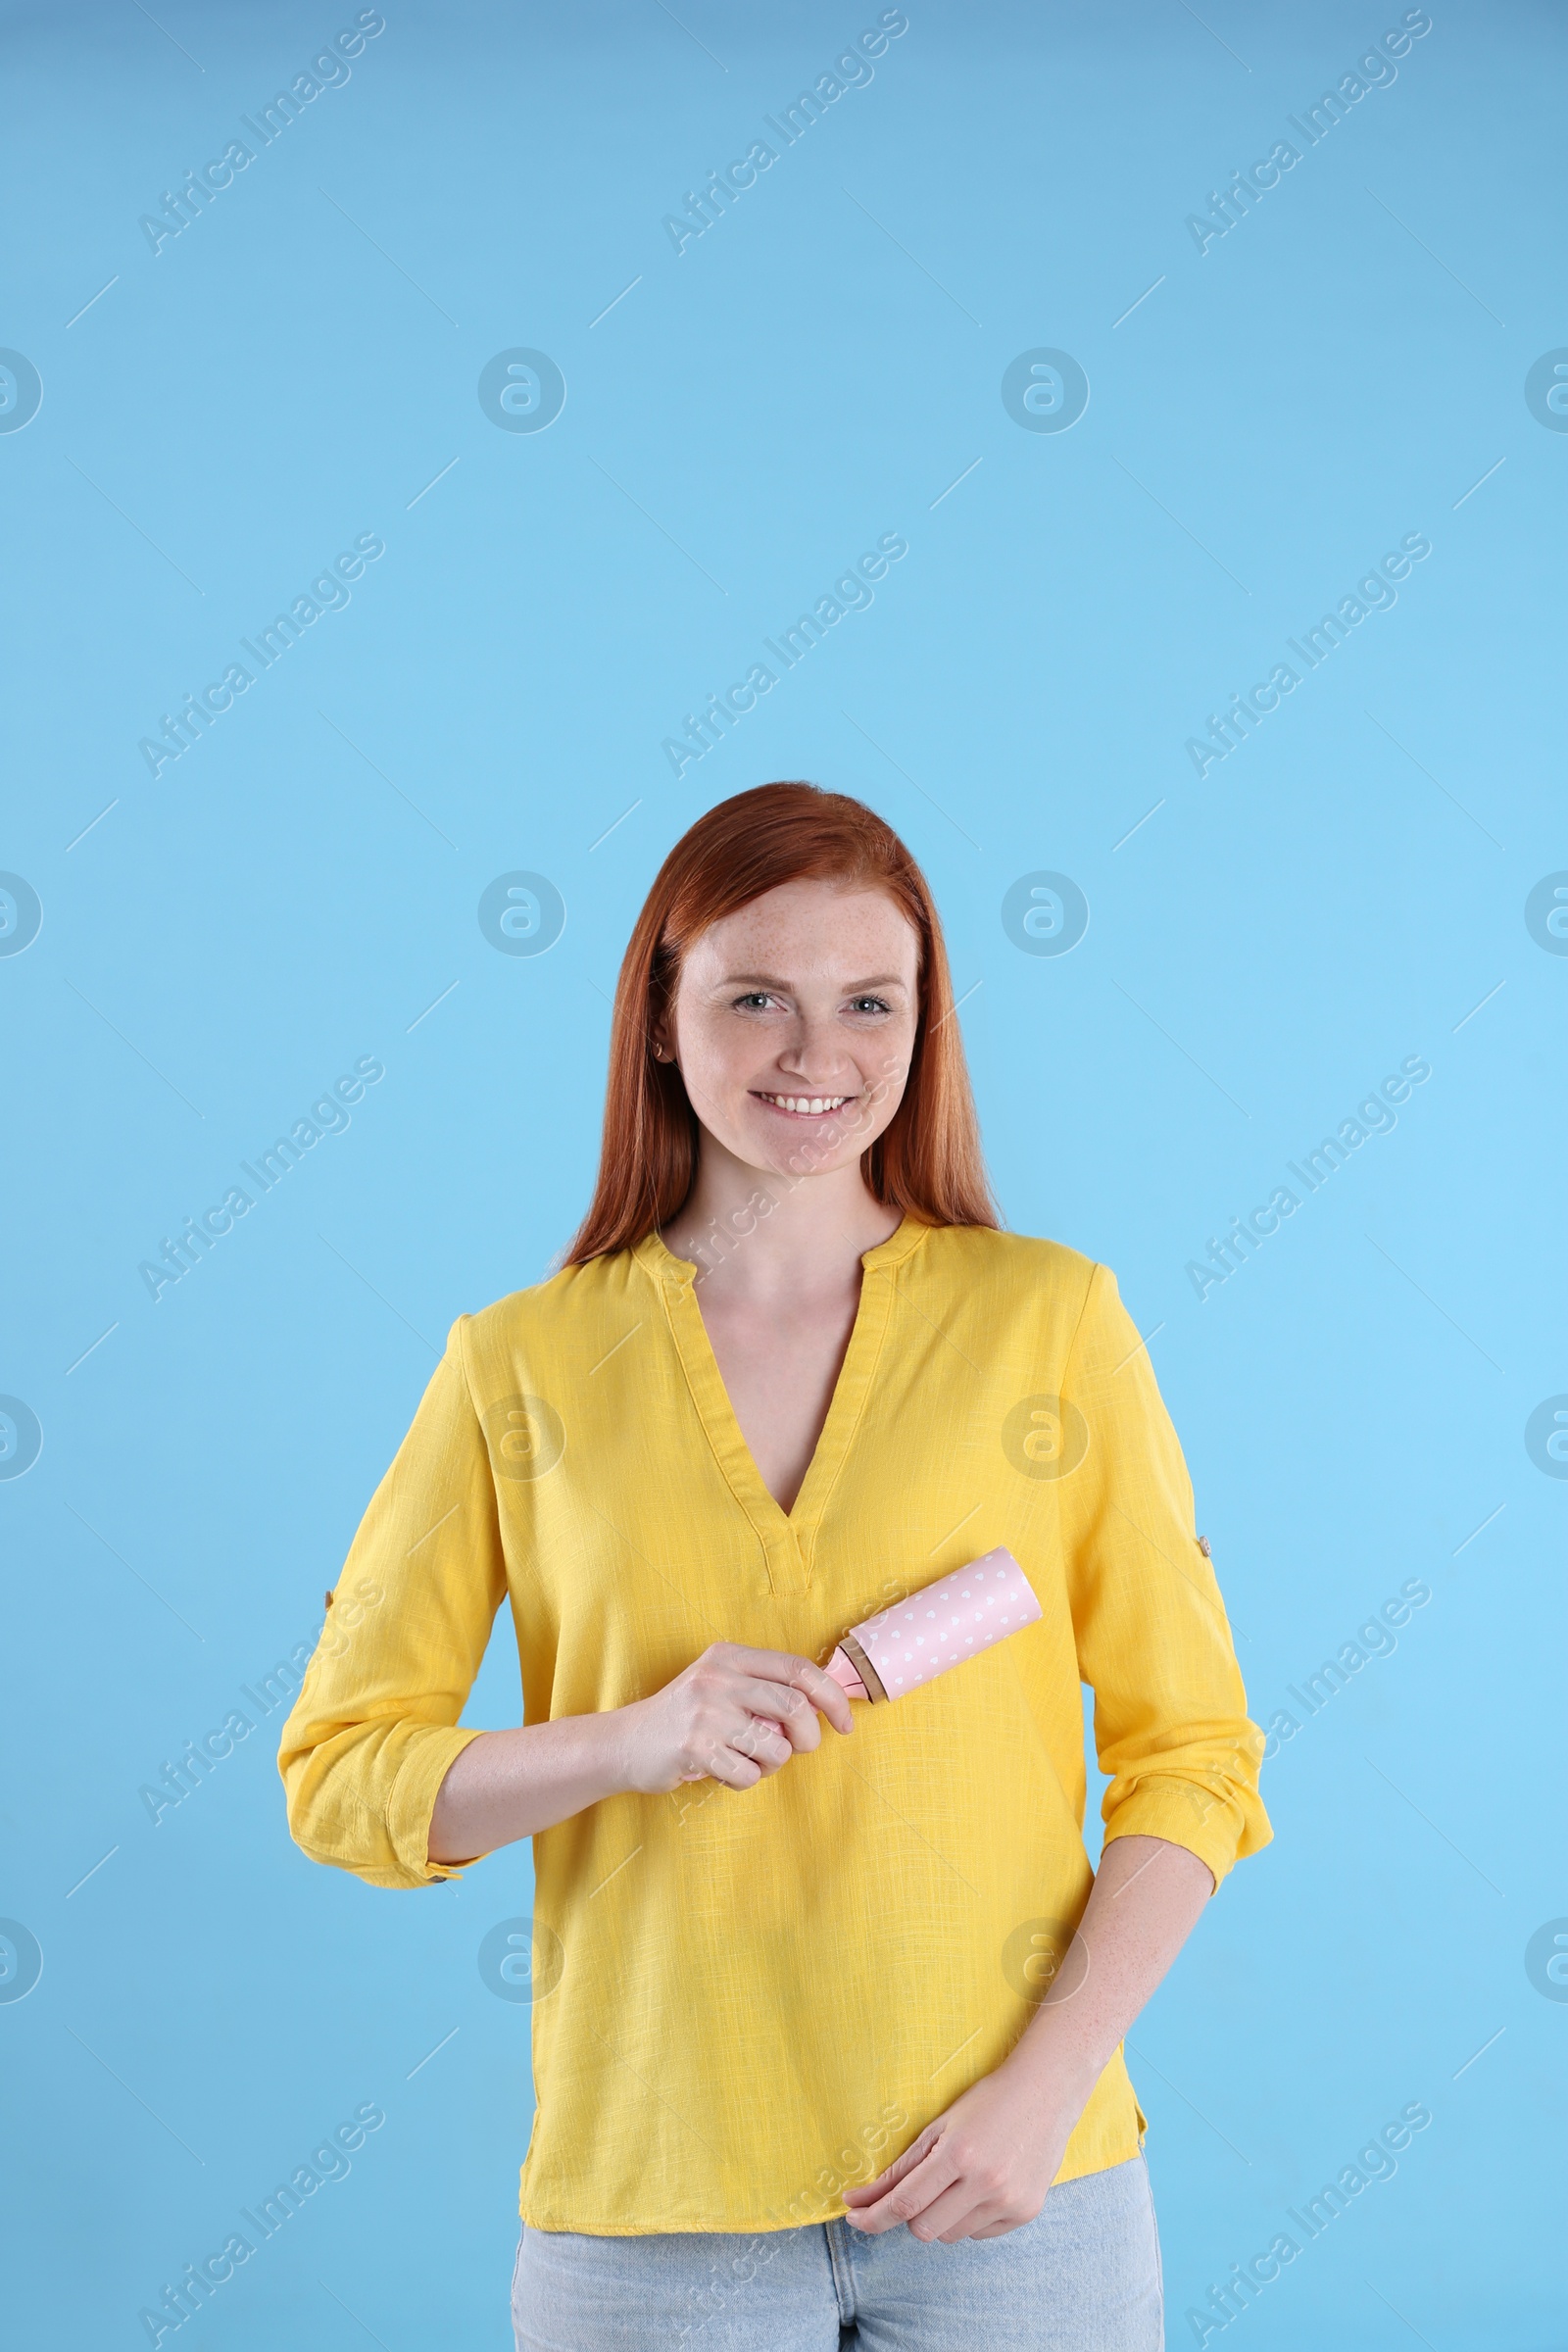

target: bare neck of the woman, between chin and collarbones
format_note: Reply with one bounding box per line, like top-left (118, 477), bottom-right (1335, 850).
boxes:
top-left (662, 1134), bottom-right (903, 1298)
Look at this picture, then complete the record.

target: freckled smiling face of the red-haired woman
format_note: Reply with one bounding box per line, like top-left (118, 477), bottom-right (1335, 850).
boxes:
top-left (662, 882), bottom-right (919, 1174)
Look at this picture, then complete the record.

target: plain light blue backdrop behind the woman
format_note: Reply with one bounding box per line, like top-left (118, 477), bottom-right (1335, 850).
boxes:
top-left (0, 0), bottom-right (1568, 2352)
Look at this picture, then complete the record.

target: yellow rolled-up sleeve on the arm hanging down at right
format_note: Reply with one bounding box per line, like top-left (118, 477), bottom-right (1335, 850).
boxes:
top-left (1060, 1265), bottom-right (1274, 1884)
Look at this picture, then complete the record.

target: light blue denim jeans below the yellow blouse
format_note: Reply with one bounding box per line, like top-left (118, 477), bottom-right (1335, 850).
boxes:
top-left (513, 2157), bottom-right (1166, 2352)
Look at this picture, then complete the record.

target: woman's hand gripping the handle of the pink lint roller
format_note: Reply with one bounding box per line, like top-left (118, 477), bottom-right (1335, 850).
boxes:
top-left (618, 1642), bottom-right (854, 1797)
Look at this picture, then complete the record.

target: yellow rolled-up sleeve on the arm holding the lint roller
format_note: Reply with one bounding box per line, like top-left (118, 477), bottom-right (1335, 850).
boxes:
top-left (277, 1317), bottom-right (506, 1886)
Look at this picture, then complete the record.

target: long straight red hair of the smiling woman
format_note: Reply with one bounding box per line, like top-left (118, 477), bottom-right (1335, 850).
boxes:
top-left (562, 783), bottom-right (999, 1265)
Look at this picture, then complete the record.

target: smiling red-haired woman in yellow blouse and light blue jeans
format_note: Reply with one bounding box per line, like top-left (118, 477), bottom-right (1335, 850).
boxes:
top-left (279, 783), bottom-right (1269, 2352)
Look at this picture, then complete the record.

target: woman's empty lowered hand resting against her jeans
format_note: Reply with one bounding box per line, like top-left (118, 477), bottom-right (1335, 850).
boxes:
top-left (844, 2060), bottom-right (1089, 2246)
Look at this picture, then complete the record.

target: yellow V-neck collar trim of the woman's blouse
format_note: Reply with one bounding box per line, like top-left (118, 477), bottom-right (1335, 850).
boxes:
top-left (632, 1216), bottom-right (931, 1592)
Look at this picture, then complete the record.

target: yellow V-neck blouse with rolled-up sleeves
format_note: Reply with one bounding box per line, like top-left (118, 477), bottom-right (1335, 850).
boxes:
top-left (279, 1218), bottom-right (1272, 2236)
